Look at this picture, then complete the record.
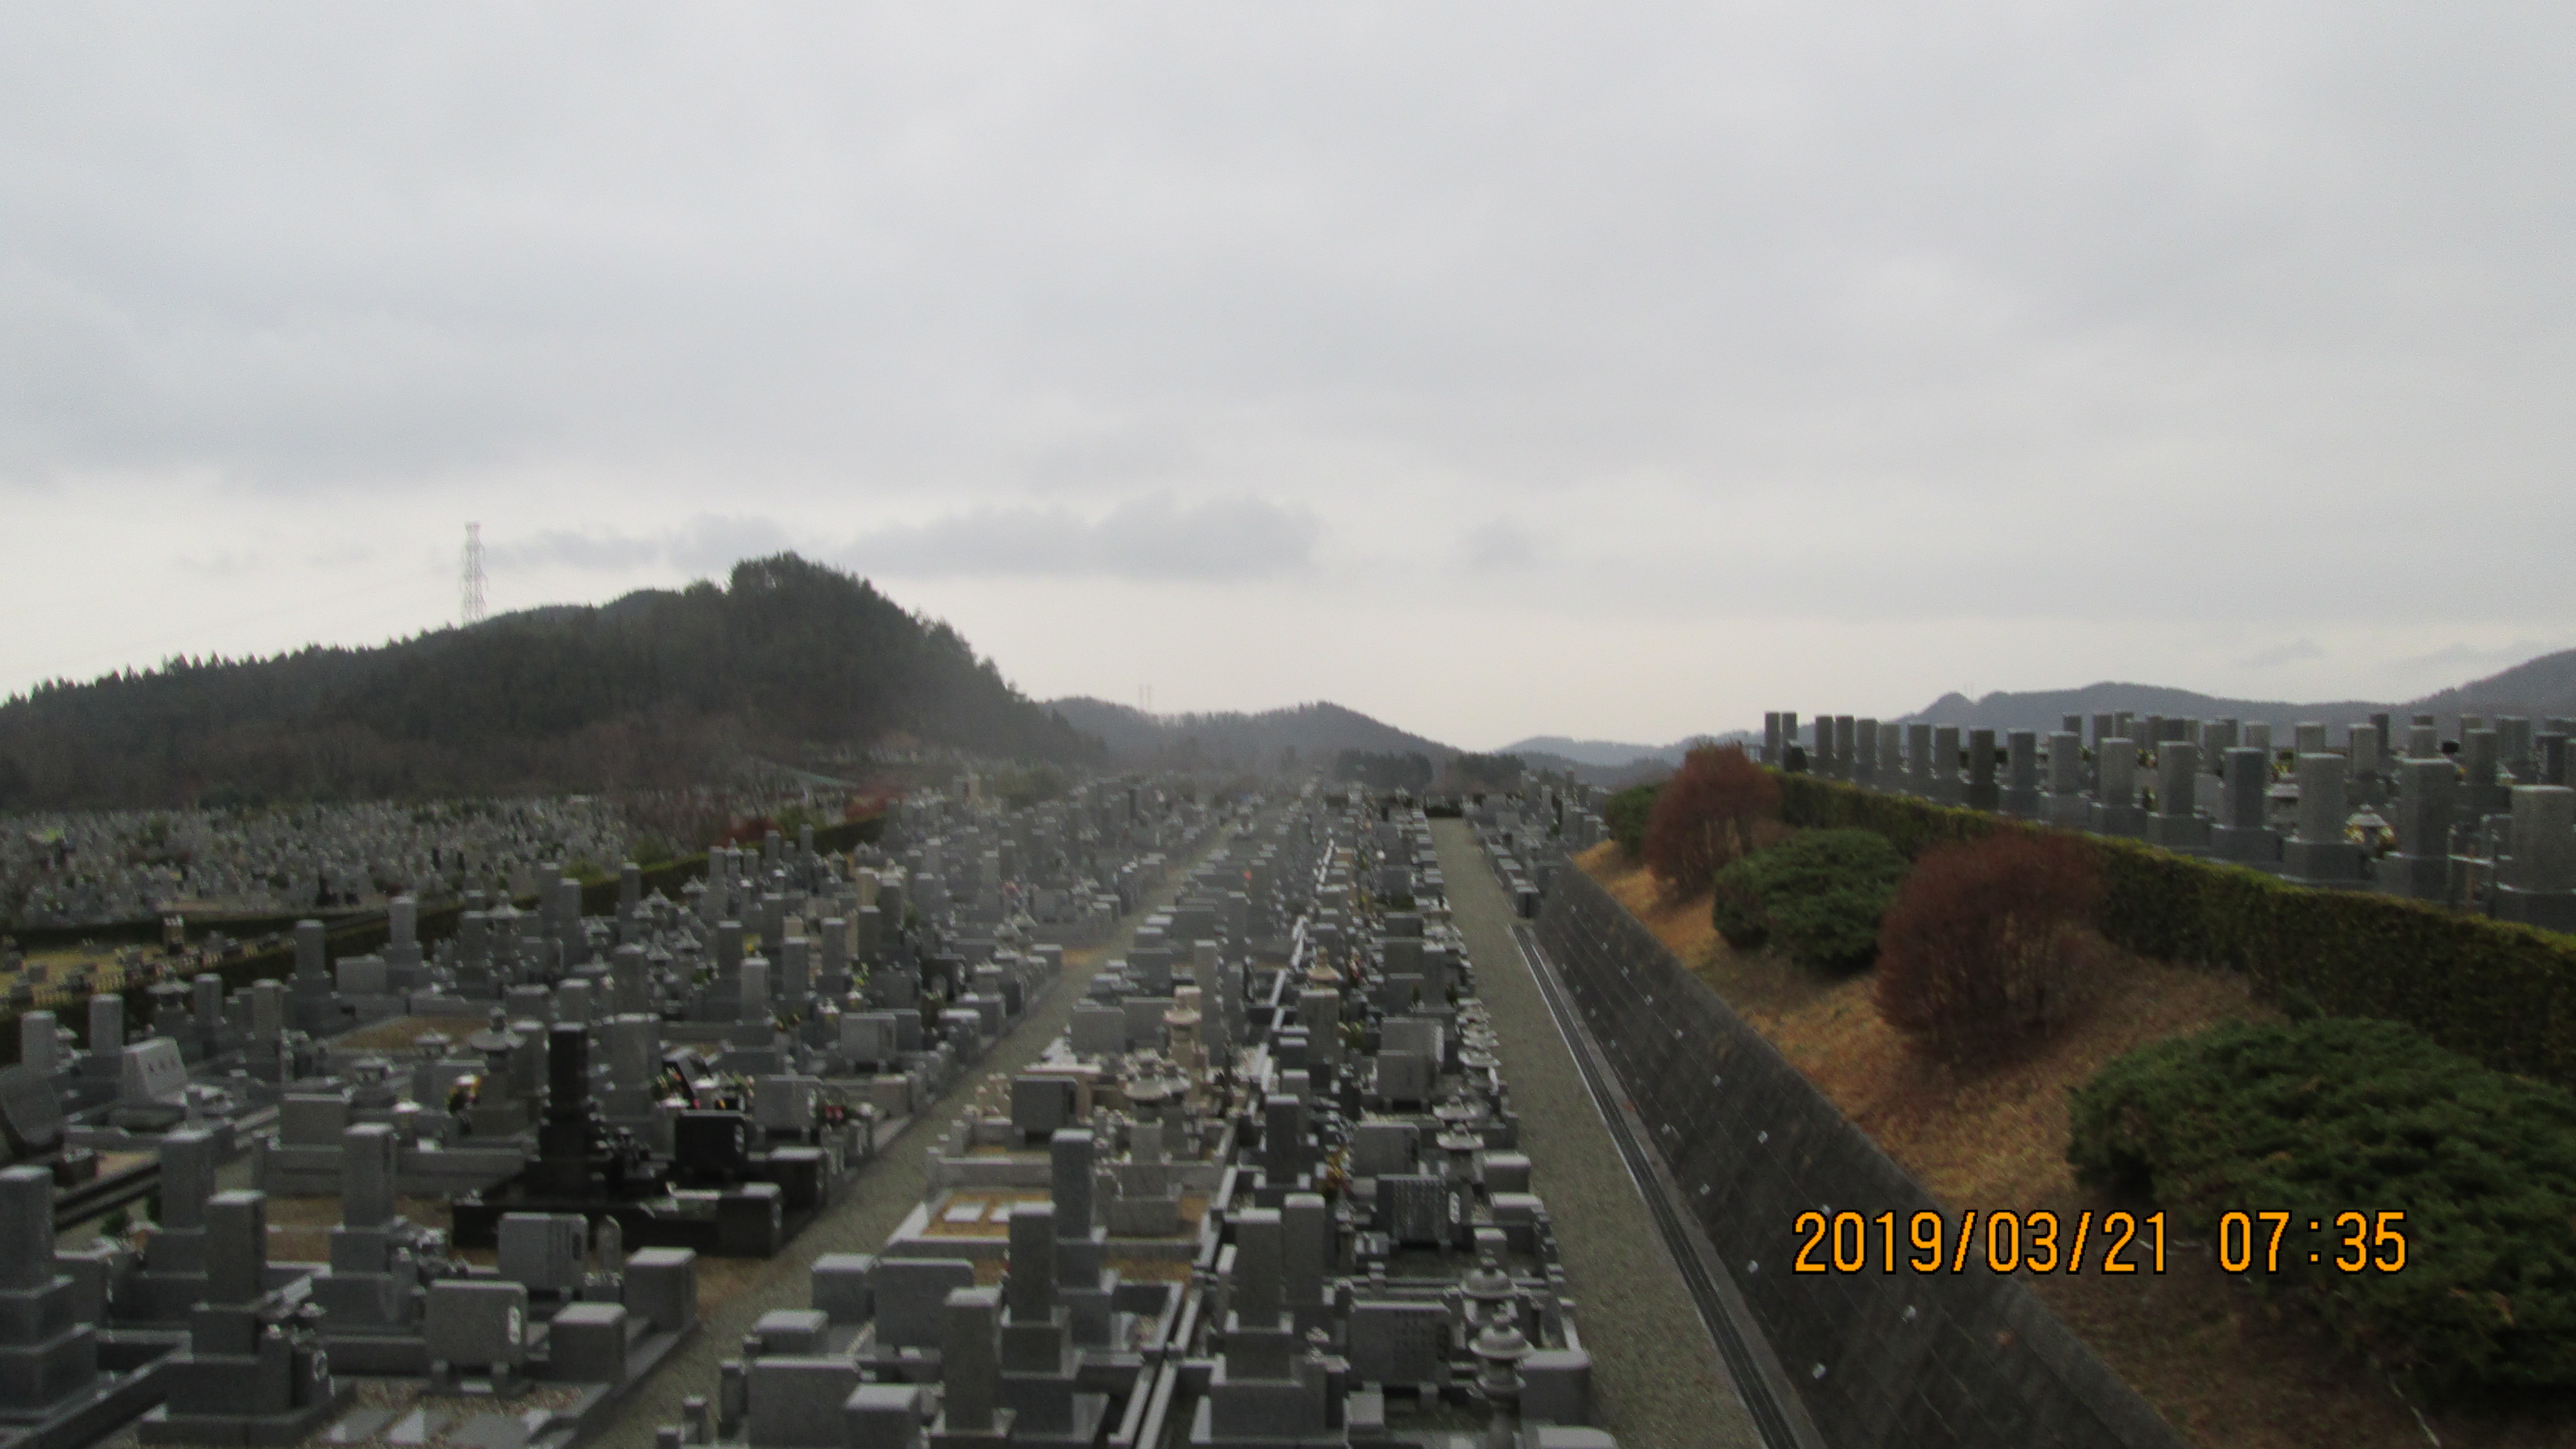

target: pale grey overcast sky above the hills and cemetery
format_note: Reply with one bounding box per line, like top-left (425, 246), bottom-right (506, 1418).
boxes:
top-left (0, 11), bottom-right (2576, 748)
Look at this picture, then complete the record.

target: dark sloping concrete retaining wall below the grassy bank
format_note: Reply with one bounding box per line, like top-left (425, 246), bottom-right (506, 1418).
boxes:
top-left (1538, 872), bottom-right (2182, 1449)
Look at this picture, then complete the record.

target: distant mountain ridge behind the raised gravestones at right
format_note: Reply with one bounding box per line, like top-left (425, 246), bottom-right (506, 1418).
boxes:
top-left (1896, 650), bottom-right (2576, 732)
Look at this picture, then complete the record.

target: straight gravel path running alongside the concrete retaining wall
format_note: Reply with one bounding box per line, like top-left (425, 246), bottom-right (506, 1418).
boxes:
top-left (1432, 820), bottom-right (1762, 1449)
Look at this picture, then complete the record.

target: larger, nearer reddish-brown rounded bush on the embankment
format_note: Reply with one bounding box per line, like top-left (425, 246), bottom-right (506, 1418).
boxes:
top-left (1878, 830), bottom-right (2102, 1062)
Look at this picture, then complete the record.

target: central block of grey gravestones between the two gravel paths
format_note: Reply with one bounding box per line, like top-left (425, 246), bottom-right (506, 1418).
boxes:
top-left (660, 797), bottom-right (1610, 1449)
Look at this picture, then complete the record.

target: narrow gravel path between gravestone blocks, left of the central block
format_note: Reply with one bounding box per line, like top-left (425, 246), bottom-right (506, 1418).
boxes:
top-left (585, 835), bottom-right (1221, 1449)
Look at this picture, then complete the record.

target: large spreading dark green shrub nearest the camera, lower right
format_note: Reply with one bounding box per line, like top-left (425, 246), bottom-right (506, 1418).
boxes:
top-left (2066, 1019), bottom-right (2576, 1393)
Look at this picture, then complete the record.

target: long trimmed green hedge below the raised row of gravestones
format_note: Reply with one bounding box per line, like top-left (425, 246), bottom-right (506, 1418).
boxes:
top-left (1778, 774), bottom-right (2576, 1086)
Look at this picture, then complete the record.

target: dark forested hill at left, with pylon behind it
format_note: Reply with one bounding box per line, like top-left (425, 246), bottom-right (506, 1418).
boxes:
top-left (0, 555), bottom-right (1105, 809)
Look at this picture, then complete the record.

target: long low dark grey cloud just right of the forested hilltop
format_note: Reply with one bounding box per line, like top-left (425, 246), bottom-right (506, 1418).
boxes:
top-left (842, 495), bottom-right (1324, 580)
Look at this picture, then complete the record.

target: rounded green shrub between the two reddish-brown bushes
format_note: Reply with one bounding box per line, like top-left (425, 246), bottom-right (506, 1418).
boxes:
top-left (1711, 830), bottom-right (1906, 972)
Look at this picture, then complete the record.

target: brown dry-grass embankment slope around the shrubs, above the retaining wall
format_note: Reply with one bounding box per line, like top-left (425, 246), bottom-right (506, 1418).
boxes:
top-left (1576, 843), bottom-right (2576, 1449)
